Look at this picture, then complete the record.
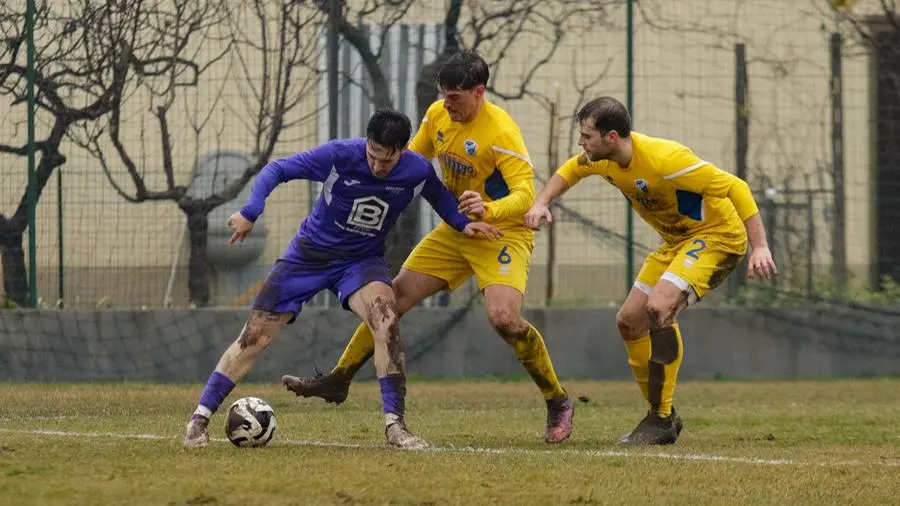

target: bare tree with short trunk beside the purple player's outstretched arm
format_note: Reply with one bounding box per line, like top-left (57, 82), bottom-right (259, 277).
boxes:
top-left (75, 0), bottom-right (322, 306)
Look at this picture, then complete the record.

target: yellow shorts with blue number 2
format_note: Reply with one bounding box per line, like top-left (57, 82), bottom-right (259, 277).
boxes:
top-left (634, 234), bottom-right (747, 304)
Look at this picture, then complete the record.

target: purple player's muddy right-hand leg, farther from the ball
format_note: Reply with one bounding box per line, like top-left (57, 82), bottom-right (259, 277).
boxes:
top-left (349, 278), bottom-right (429, 450)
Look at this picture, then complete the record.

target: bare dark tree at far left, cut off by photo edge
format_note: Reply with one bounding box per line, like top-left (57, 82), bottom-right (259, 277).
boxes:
top-left (0, 0), bottom-right (145, 305)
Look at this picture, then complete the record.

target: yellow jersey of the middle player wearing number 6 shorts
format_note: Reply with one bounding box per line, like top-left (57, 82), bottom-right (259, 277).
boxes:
top-left (409, 100), bottom-right (534, 233)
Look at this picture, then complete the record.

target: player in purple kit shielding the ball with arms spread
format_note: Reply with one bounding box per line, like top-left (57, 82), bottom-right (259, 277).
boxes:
top-left (184, 110), bottom-right (500, 449)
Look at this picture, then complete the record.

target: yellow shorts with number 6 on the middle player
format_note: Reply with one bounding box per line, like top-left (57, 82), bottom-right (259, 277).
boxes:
top-left (403, 223), bottom-right (534, 295)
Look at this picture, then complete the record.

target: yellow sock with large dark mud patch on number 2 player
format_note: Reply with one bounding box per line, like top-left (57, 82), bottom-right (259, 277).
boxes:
top-left (648, 323), bottom-right (684, 416)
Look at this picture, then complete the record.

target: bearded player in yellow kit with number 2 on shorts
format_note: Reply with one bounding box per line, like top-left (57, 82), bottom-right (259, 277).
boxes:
top-left (525, 97), bottom-right (776, 444)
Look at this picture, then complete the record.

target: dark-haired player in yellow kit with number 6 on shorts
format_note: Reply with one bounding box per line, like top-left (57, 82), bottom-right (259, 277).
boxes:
top-left (282, 51), bottom-right (574, 443)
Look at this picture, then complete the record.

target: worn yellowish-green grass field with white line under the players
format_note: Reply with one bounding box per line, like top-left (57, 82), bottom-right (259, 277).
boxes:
top-left (0, 380), bottom-right (900, 505)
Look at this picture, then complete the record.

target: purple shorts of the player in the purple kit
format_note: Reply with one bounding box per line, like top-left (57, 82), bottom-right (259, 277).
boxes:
top-left (253, 257), bottom-right (392, 323)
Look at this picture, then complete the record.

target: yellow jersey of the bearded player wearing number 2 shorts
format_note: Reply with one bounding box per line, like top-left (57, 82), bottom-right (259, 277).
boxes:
top-left (557, 132), bottom-right (759, 244)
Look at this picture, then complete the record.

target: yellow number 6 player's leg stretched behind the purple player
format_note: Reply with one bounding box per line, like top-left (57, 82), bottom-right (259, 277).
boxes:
top-left (282, 224), bottom-right (472, 404)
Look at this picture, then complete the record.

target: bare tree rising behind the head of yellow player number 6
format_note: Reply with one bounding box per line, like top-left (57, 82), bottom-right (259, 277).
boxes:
top-left (319, 0), bottom-right (616, 270)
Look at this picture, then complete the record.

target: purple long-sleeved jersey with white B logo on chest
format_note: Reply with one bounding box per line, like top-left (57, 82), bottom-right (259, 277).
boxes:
top-left (241, 139), bottom-right (471, 261)
